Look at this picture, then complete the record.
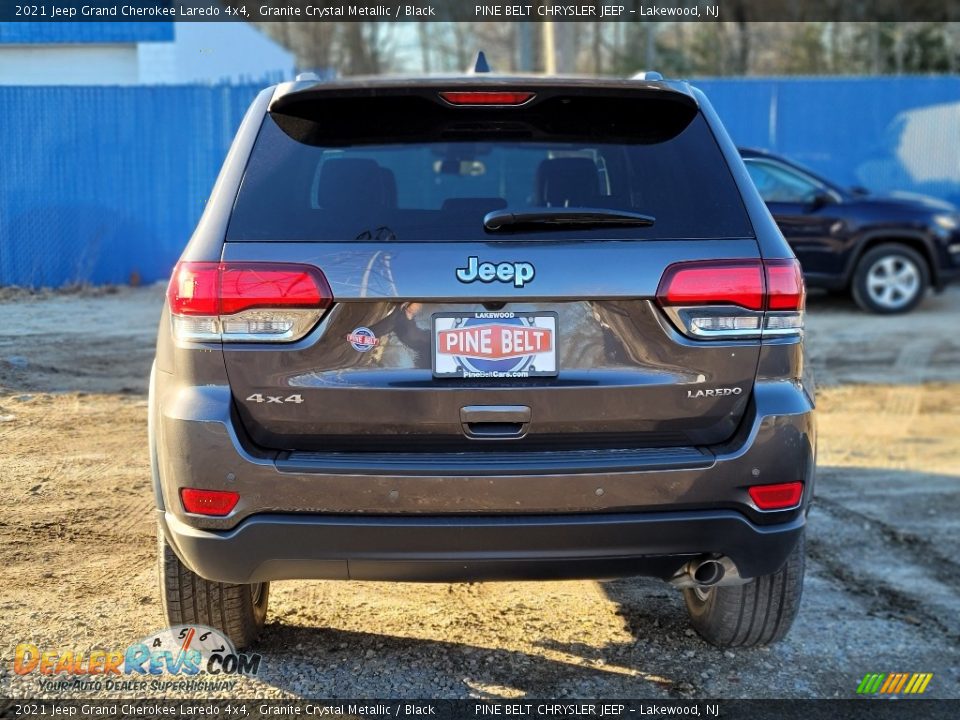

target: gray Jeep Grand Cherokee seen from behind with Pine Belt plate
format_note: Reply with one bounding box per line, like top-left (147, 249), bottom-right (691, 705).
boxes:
top-left (150, 70), bottom-right (815, 647)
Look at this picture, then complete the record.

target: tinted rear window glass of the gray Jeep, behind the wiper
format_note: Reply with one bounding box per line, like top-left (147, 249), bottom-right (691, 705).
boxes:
top-left (227, 102), bottom-right (753, 242)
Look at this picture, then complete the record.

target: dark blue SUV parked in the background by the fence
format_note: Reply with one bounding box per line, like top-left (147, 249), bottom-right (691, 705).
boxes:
top-left (740, 149), bottom-right (960, 313)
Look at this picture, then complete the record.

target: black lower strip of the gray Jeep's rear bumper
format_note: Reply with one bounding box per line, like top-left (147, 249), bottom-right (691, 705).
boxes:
top-left (158, 510), bottom-right (805, 583)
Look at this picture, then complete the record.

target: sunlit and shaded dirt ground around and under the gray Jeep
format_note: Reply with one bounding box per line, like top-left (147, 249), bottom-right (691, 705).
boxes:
top-left (0, 288), bottom-right (960, 698)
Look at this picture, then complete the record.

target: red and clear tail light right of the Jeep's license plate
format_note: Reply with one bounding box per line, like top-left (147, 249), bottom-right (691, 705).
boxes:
top-left (657, 260), bottom-right (805, 339)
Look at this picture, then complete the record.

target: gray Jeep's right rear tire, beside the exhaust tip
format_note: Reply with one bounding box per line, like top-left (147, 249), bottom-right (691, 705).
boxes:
top-left (683, 535), bottom-right (805, 647)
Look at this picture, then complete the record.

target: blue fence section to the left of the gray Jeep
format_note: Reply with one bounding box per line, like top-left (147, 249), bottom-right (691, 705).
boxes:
top-left (0, 86), bottom-right (259, 287)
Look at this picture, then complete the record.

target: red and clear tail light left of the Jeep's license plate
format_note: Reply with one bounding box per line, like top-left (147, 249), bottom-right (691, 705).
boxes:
top-left (167, 262), bottom-right (333, 342)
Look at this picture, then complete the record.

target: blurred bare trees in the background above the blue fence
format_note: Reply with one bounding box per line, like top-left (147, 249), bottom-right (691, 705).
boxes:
top-left (255, 18), bottom-right (960, 77)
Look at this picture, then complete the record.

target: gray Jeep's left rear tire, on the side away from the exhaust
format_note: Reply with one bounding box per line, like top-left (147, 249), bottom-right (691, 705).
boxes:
top-left (157, 528), bottom-right (270, 650)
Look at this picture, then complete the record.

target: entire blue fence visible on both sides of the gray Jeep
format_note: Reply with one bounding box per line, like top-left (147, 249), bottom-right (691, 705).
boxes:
top-left (0, 77), bottom-right (960, 287)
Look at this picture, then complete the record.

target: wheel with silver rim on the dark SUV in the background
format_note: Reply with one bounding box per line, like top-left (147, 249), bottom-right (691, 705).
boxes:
top-left (850, 243), bottom-right (930, 315)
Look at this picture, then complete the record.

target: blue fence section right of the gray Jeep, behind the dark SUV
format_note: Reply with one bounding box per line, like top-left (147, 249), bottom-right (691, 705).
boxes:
top-left (694, 76), bottom-right (960, 202)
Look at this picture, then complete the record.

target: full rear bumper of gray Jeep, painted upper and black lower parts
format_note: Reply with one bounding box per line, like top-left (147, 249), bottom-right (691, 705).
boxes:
top-left (153, 372), bottom-right (816, 583)
